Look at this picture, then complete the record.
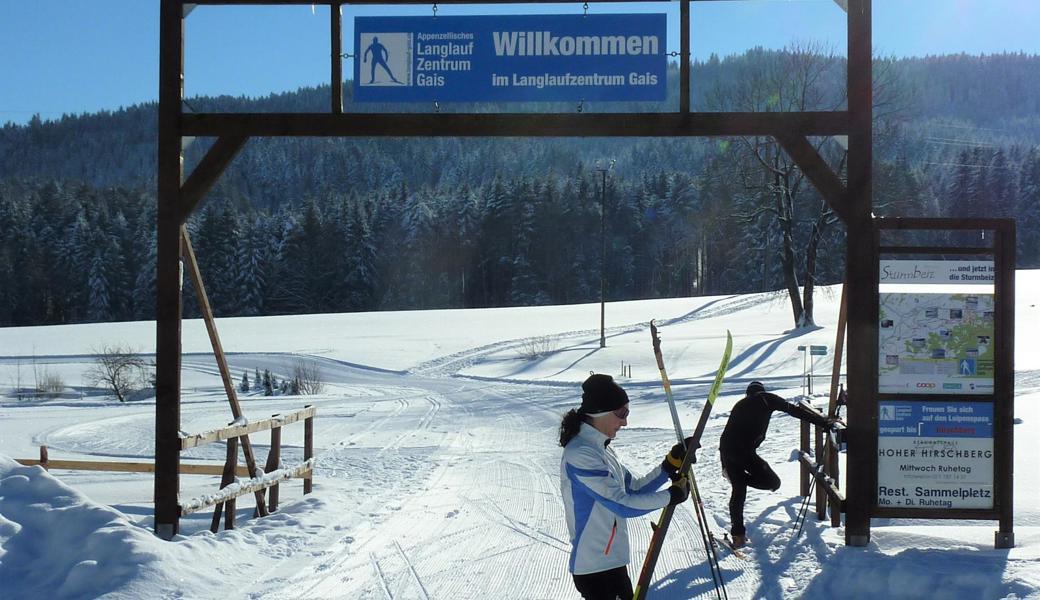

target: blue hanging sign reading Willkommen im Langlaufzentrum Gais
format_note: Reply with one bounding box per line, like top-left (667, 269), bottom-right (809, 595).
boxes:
top-left (354, 14), bottom-right (668, 102)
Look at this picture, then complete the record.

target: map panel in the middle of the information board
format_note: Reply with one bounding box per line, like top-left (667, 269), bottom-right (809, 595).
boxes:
top-left (878, 293), bottom-right (996, 395)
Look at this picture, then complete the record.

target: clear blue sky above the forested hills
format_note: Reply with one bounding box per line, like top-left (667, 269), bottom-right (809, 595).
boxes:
top-left (0, 0), bottom-right (1040, 123)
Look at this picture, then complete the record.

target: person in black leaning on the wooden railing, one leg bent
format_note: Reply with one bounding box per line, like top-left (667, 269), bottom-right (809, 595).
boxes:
top-left (719, 382), bottom-right (831, 548)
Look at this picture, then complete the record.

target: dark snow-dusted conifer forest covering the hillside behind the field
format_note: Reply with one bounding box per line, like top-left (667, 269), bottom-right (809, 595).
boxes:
top-left (0, 47), bottom-right (1040, 325)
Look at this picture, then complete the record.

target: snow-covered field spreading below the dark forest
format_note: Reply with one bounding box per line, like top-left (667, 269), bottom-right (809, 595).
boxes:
top-left (0, 271), bottom-right (1040, 599)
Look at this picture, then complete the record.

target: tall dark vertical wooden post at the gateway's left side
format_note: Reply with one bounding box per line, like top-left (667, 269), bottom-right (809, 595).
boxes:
top-left (154, 0), bottom-right (184, 540)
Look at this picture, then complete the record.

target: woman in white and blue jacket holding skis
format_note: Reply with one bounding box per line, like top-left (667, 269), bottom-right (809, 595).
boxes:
top-left (560, 374), bottom-right (690, 600)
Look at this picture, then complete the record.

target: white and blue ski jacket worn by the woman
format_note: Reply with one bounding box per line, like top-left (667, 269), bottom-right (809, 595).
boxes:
top-left (560, 423), bottom-right (671, 575)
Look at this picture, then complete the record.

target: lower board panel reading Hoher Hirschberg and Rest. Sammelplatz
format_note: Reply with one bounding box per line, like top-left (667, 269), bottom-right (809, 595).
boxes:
top-left (878, 400), bottom-right (993, 510)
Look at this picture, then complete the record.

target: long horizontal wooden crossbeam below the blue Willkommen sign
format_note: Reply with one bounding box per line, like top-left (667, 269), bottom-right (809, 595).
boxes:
top-left (182, 111), bottom-right (849, 137)
